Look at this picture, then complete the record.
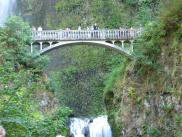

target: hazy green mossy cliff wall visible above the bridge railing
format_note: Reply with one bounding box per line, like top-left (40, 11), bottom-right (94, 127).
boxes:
top-left (17, 0), bottom-right (159, 29)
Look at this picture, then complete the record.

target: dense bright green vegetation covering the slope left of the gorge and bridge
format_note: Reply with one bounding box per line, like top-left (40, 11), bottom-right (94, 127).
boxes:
top-left (0, 17), bottom-right (70, 137)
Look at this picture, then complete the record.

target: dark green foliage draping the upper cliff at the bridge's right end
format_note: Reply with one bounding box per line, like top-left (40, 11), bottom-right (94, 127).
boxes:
top-left (135, 0), bottom-right (182, 73)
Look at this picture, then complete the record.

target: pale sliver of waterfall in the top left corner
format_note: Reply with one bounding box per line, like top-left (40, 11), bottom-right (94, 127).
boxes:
top-left (0, 0), bottom-right (15, 25)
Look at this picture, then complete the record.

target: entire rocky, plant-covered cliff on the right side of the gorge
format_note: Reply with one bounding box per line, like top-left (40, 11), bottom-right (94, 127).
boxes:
top-left (105, 0), bottom-right (182, 137)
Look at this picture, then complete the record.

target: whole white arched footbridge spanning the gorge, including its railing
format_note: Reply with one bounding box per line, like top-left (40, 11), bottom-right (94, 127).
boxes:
top-left (31, 28), bottom-right (141, 58)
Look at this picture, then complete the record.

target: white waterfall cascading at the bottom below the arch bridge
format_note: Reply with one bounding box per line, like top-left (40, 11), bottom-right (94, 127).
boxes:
top-left (70, 116), bottom-right (112, 137)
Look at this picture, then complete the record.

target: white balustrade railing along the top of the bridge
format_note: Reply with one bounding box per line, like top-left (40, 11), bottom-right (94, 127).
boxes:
top-left (31, 29), bottom-right (141, 41)
